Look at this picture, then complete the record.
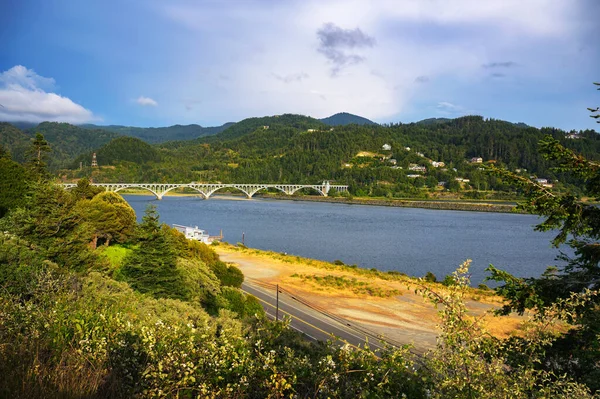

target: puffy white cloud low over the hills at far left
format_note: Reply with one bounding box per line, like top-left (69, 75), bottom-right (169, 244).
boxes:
top-left (0, 65), bottom-right (100, 124)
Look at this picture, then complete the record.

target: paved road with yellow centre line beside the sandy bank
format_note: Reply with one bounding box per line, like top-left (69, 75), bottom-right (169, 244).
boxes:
top-left (242, 282), bottom-right (382, 352)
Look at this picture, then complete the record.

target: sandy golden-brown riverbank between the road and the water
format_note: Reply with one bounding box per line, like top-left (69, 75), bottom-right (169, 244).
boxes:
top-left (214, 245), bottom-right (524, 350)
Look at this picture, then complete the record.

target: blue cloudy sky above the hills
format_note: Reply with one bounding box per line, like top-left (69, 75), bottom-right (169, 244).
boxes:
top-left (0, 0), bottom-right (600, 130)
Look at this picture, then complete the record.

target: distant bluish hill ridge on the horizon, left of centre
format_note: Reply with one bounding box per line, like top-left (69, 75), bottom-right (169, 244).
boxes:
top-left (81, 122), bottom-right (233, 144)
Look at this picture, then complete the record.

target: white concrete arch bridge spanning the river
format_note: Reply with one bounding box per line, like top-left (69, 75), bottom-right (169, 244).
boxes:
top-left (63, 181), bottom-right (348, 200)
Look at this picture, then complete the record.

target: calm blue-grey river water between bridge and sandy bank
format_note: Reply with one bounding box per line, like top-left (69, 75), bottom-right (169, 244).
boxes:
top-left (125, 196), bottom-right (558, 284)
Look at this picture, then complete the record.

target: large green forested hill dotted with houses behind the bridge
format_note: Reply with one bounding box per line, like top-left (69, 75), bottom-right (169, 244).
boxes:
top-left (62, 114), bottom-right (600, 196)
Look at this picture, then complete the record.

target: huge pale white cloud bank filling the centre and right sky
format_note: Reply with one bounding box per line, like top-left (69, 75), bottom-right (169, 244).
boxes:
top-left (155, 0), bottom-right (581, 122)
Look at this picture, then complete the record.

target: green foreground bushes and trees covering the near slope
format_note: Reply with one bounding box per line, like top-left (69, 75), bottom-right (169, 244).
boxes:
top-left (0, 132), bottom-right (598, 398)
